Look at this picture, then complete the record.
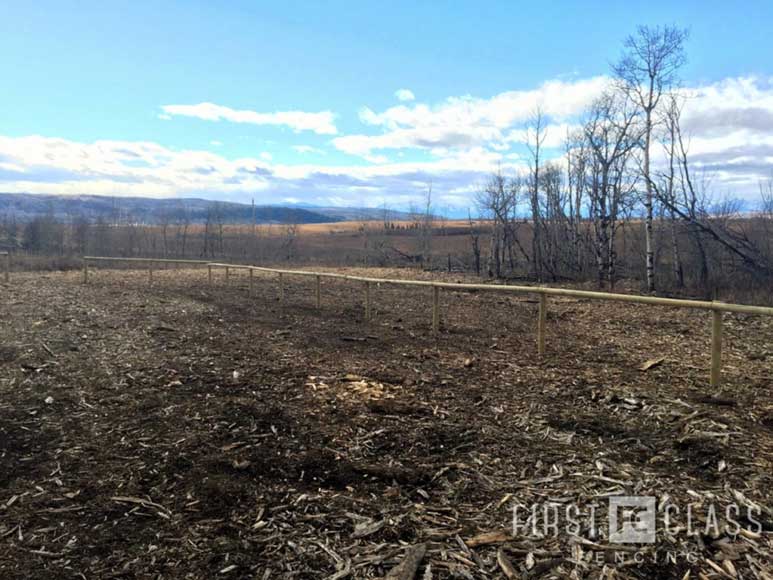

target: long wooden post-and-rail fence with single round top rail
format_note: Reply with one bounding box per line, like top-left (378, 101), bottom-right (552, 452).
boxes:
top-left (83, 256), bottom-right (773, 387)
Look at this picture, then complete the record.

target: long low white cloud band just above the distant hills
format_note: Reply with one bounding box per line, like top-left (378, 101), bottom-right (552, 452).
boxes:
top-left (0, 136), bottom-right (501, 206)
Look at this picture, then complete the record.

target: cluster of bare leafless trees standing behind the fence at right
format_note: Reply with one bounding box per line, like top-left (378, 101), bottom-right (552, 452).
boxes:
top-left (472, 27), bottom-right (773, 291)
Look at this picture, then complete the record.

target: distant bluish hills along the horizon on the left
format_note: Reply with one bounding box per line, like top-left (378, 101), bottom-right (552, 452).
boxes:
top-left (0, 193), bottom-right (409, 224)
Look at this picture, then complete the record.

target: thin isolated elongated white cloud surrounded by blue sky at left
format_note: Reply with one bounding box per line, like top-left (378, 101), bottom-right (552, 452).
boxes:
top-left (161, 103), bottom-right (338, 135)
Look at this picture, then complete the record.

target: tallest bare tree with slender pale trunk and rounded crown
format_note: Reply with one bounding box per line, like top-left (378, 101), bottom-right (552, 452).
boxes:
top-left (613, 26), bottom-right (687, 292)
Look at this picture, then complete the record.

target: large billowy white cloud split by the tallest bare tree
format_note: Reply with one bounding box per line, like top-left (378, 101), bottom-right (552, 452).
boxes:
top-left (332, 77), bottom-right (773, 203)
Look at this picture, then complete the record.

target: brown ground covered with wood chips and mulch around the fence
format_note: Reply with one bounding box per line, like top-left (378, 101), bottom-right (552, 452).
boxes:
top-left (0, 270), bottom-right (773, 579)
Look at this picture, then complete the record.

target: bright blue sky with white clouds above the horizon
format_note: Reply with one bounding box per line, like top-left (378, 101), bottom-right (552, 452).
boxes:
top-left (0, 1), bottom-right (773, 209)
